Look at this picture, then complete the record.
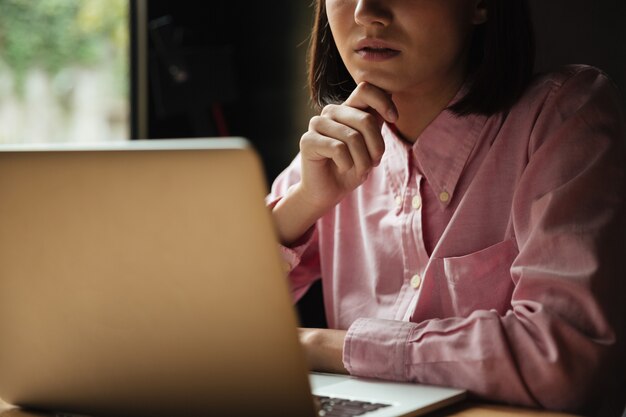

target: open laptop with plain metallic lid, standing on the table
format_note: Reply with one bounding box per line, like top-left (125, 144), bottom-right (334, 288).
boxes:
top-left (0, 138), bottom-right (465, 417)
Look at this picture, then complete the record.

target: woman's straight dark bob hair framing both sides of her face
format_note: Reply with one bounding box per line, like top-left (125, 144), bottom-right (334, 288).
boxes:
top-left (309, 0), bottom-right (535, 115)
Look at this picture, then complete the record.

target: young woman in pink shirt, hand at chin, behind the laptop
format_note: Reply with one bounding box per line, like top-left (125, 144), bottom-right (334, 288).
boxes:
top-left (268, 0), bottom-right (625, 412)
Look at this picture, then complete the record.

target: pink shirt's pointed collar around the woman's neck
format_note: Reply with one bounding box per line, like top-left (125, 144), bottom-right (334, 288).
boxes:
top-left (383, 101), bottom-right (487, 207)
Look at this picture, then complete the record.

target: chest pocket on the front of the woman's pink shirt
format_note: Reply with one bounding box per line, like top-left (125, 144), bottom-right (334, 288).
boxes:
top-left (436, 239), bottom-right (518, 317)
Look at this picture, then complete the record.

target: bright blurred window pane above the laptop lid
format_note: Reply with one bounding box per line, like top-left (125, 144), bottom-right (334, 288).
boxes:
top-left (0, 0), bottom-right (130, 143)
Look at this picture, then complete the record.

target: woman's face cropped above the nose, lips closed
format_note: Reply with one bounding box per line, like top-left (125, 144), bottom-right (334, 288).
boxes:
top-left (322, 0), bottom-right (487, 94)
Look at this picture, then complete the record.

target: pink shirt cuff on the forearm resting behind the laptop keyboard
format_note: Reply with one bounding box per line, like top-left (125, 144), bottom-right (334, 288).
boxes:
top-left (343, 318), bottom-right (415, 381)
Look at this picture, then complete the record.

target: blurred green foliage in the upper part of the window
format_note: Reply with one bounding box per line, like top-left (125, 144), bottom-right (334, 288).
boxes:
top-left (0, 0), bottom-right (129, 89)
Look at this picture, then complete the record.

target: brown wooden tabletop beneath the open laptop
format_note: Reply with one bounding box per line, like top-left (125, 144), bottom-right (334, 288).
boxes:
top-left (0, 400), bottom-right (575, 417)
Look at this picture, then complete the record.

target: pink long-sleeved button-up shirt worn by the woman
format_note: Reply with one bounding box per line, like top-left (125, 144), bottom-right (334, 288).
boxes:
top-left (268, 66), bottom-right (625, 410)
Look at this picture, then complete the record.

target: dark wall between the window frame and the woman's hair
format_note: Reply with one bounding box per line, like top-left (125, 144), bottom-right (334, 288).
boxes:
top-left (142, 0), bottom-right (306, 181)
